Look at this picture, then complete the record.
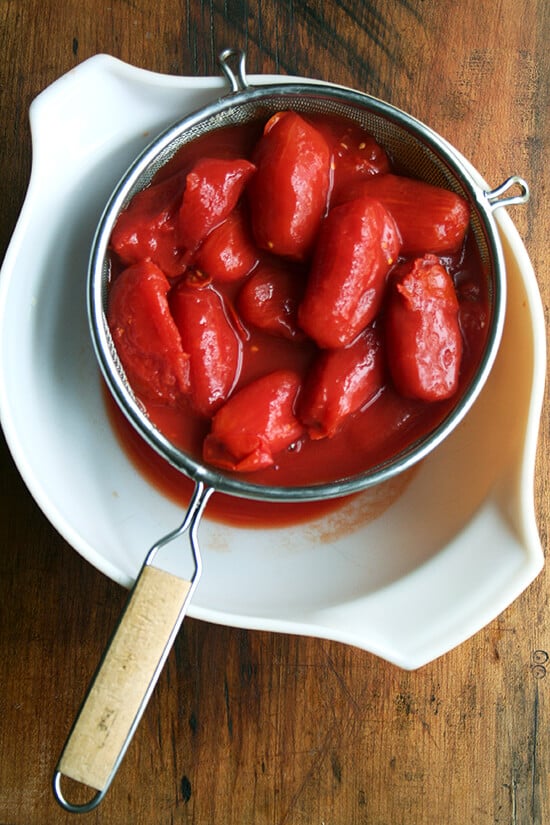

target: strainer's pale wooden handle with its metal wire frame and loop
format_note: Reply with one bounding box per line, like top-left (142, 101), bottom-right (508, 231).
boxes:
top-left (53, 482), bottom-right (213, 813)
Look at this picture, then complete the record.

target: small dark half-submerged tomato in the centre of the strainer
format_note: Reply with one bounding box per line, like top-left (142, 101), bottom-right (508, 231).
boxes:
top-left (237, 254), bottom-right (305, 340)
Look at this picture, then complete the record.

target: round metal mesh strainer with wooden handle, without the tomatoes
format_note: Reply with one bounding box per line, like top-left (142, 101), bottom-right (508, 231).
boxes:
top-left (53, 50), bottom-right (529, 813)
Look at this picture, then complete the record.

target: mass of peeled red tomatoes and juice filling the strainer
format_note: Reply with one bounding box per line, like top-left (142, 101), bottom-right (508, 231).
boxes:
top-left (104, 112), bottom-right (488, 523)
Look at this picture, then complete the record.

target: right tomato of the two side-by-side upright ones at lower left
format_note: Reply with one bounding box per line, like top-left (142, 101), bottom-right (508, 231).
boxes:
top-left (170, 282), bottom-right (241, 416)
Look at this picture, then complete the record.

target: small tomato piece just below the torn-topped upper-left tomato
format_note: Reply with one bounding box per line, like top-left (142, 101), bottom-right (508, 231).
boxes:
top-left (194, 208), bottom-right (258, 281)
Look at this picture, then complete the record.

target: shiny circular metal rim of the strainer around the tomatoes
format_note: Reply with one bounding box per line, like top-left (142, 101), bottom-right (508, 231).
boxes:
top-left (87, 66), bottom-right (506, 501)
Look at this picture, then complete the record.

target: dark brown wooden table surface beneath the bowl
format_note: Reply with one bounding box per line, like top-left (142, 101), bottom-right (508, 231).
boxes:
top-left (0, 0), bottom-right (550, 825)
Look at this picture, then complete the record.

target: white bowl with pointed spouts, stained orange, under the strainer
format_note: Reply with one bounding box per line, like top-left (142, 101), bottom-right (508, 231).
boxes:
top-left (0, 55), bottom-right (546, 668)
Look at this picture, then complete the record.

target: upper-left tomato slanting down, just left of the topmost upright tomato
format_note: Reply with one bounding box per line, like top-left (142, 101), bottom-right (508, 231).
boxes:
top-left (179, 158), bottom-right (256, 251)
